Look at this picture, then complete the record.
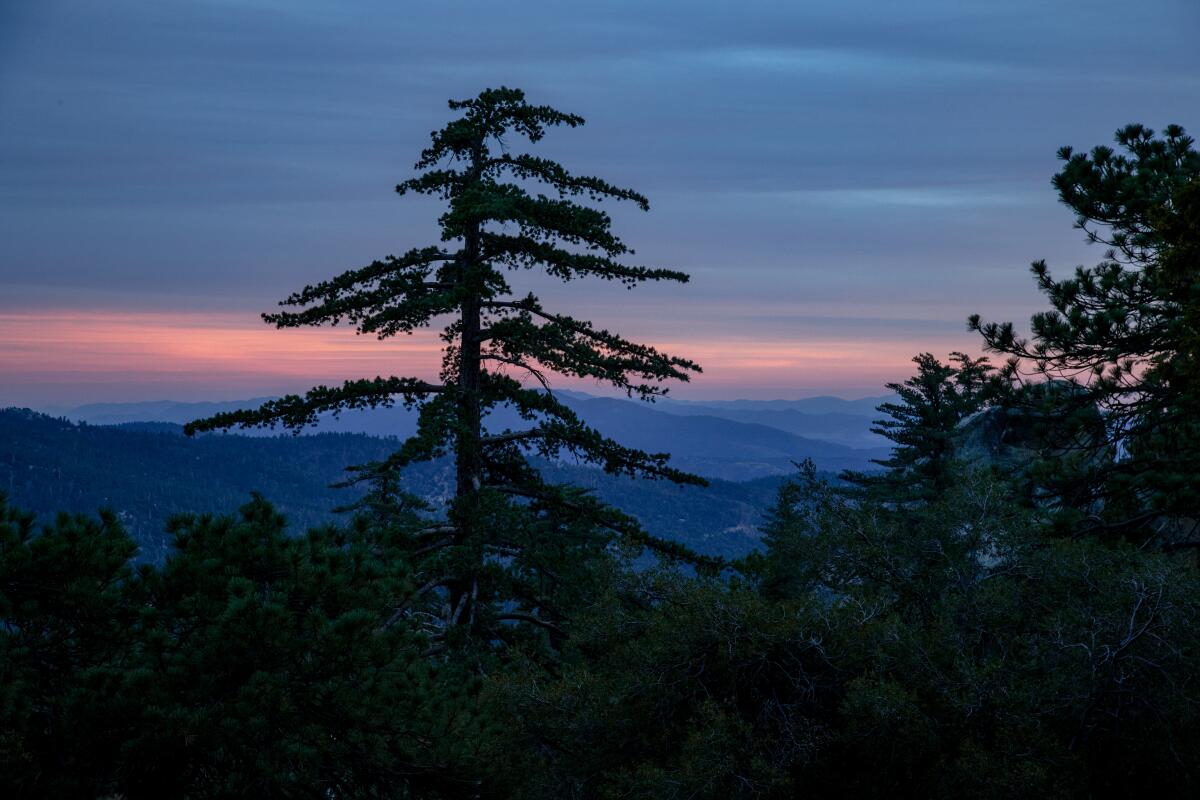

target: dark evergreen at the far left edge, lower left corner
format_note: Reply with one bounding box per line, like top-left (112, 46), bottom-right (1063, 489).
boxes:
top-left (0, 492), bottom-right (140, 798)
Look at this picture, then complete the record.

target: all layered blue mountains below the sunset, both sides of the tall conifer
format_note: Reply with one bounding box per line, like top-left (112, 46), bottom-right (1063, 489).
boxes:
top-left (0, 391), bottom-right (889, 560)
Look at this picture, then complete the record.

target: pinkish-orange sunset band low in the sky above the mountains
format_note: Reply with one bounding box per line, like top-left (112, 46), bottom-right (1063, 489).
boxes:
top-left (0, 311), bottom-right (969, 402)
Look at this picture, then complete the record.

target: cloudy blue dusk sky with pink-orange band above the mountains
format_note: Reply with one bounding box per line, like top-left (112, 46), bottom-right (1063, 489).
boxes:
top-left (0, 0), bottom-right (1200, 407)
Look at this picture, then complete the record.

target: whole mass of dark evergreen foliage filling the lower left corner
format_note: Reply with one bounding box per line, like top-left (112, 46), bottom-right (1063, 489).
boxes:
top-left (0, 499), bottom-right (484, 798)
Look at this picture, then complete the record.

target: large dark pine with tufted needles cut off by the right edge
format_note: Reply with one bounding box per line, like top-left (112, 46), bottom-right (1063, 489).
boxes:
top-left (970, 125), bottom-right (1200, 537)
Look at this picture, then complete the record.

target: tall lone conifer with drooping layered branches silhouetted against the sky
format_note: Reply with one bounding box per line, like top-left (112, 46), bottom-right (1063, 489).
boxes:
top-left (187, 88), bottom-right (703, 640)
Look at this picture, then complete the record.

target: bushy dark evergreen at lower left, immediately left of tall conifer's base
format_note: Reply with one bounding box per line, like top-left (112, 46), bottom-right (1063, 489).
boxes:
top-left (118, 498), bottom-right (484, 798)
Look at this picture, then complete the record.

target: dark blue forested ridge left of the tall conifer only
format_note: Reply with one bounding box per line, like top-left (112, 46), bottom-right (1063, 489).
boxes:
top-left (0, 409), bottom-right (395, 560)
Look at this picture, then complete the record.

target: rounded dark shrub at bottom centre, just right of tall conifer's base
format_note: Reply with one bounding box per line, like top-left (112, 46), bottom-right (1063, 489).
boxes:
top-left (485, 573), bottom-right (833, 799)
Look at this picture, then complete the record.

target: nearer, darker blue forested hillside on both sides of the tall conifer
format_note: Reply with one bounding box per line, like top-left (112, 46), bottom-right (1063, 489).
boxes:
top-left (0, 409), bottom-right (796, 560)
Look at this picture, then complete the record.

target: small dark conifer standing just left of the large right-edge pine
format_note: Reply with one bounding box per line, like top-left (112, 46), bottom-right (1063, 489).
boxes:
top-left (841, 353), bottom-right (991, 503)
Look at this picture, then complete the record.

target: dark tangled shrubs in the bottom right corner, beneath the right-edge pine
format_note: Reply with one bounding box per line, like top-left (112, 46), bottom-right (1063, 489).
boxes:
top-left (768, 474), bottom-right (1200, 796)
